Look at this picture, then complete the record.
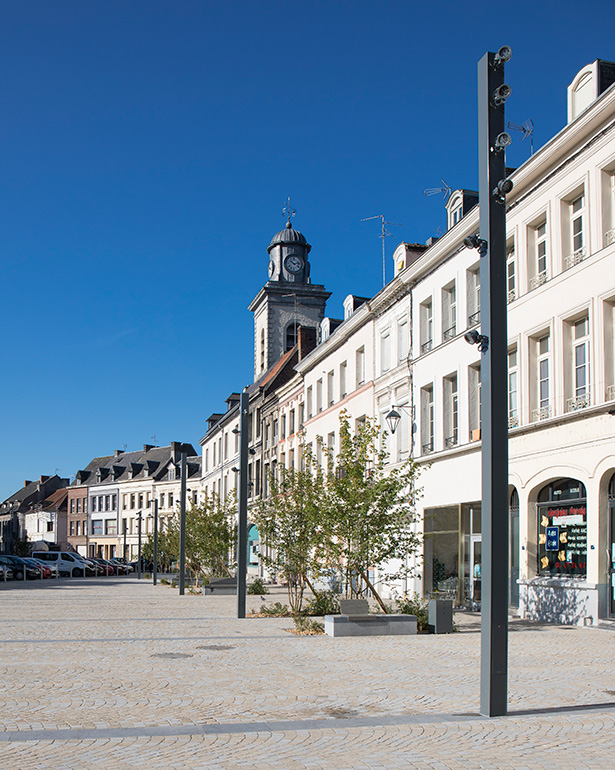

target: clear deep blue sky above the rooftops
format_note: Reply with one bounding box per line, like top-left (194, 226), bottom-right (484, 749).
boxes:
top-left (0, 0), bottom-right (615, 499)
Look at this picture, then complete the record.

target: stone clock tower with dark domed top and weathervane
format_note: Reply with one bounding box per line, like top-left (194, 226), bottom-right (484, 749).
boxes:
top-left (248, 217), bottom-right (331, 381)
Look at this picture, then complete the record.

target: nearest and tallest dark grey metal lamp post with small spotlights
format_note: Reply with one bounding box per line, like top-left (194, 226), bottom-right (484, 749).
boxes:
top-left (476, 46), bottom-right (513, 717)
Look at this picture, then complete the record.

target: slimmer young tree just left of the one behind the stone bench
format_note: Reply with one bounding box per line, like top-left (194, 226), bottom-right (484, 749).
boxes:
top-left (254, 450), bottom-right (326, 612)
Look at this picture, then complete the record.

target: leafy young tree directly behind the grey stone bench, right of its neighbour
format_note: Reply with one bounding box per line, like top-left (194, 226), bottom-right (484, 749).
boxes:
top-left (322, 411), bottom-right (421, 612)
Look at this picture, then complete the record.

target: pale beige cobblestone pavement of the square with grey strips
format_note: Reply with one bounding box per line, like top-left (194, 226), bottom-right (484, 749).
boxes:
top-left (0, 578), bottom-right (615, 770)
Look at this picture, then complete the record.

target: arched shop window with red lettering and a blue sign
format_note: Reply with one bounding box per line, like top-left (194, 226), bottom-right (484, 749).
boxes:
top-left (537, 479), bottom-right (587, 576)
